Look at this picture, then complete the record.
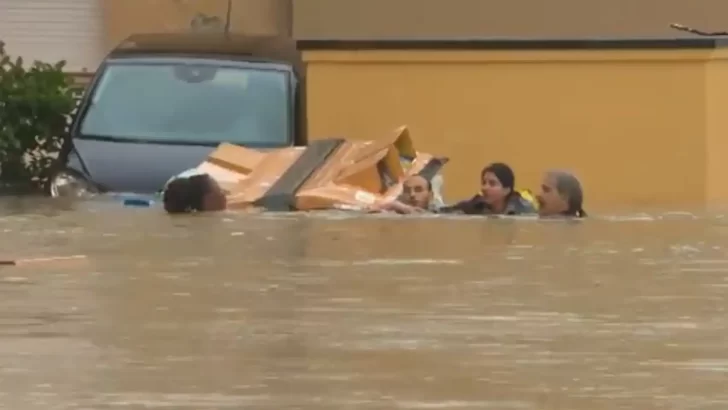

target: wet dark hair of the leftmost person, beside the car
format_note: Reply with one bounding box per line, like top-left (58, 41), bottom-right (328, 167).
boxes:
top-left (162, 174), bottom-right (212, 214)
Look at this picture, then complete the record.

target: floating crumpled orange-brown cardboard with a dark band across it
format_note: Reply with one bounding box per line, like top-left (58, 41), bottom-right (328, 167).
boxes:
top-left (199, 127), bottom-right (448, 211)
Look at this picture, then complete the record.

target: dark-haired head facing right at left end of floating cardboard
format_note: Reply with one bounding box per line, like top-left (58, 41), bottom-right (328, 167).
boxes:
top-left (162, 174), bottom-right (227, 214)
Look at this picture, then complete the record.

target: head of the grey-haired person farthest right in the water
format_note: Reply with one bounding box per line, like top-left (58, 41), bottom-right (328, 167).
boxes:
top-left (536, 171), bottom-right (586, 218)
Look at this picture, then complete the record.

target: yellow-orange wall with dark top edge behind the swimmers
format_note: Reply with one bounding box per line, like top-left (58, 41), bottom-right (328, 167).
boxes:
top-left (304, 50), bottom-right (728, 208)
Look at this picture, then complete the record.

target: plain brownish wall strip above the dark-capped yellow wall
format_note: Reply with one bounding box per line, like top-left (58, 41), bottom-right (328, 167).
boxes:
top-left (293, 0), bottom-right (728, 39)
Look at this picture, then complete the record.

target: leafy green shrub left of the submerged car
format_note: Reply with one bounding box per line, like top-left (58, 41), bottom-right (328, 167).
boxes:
top-left (0, 41), bottom-right (77, 191)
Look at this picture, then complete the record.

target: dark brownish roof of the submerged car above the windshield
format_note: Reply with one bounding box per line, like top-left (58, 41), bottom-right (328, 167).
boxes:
top-left (108, 32), bottom-right (302, 68)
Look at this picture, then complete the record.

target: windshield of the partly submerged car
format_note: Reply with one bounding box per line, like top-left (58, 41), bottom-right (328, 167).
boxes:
top-left (80, 63), bottom-right (291, 146)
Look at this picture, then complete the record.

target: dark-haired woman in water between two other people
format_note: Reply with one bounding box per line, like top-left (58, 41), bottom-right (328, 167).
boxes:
top-left (439, 162), bottom-right (537, 215)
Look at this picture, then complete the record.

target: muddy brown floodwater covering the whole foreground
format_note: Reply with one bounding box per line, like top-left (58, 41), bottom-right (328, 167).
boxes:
top-left (0, 200), bottom-right (728, 410)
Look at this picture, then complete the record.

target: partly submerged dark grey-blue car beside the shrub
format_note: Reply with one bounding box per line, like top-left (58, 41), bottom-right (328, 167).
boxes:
top-left (48, 33), bottom-right (307, 196)
